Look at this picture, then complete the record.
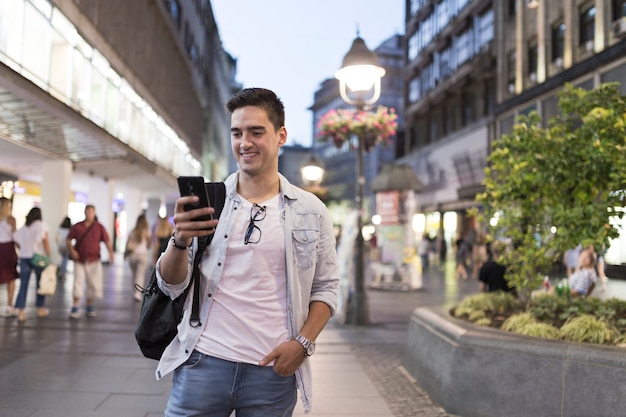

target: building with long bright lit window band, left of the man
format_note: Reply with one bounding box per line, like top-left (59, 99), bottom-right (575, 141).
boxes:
top-left (0, 0), bottom-right (238, 254)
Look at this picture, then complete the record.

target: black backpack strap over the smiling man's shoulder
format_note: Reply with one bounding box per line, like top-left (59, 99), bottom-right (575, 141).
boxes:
top-left (189, 182), bottom-right (226, 327)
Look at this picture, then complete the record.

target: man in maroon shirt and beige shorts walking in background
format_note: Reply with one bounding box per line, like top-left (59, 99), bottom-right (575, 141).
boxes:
top-left (67, 204), bottom-right (115, 319)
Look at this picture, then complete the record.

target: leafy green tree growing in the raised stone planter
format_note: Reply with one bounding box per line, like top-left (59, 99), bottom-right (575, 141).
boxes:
top-left (477, 83), bottom-right (626, 303)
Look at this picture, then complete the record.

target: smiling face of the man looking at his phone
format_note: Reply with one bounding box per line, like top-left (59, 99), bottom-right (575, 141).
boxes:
top-left (230, 106), bottom-right (287, 176)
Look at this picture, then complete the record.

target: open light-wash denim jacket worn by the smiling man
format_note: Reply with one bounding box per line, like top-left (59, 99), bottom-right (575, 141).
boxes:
top-left (156, 172), bottom-right (339, 412)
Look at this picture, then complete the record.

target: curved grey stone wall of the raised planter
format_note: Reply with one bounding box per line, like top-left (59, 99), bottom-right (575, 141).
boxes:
top-left (403, 308), bottom-right (626, 417)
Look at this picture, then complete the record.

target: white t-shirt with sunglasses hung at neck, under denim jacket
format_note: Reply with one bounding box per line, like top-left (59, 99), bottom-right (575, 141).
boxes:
top-left (196, 195), bottom-right (289, 364)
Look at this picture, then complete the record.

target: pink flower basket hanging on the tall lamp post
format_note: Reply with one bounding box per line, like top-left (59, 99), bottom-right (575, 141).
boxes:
top-left (317, 106), bottom-right (398, 152)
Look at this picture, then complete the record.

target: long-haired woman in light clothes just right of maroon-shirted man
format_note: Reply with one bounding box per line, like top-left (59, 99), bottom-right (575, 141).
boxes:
top-left (124, 214), bottom-right (152, 301)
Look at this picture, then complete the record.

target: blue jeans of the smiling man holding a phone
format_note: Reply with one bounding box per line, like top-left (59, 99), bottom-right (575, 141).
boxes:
top-left (165, 350), bottom-right (297, 417)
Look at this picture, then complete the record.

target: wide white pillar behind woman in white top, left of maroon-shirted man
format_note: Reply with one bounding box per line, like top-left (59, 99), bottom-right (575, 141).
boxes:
top-left (41, 161), bottom-right (72, 265)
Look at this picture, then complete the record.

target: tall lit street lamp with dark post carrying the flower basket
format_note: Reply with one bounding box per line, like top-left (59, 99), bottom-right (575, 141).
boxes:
top-left (335, 32), bottom-right (385, 325)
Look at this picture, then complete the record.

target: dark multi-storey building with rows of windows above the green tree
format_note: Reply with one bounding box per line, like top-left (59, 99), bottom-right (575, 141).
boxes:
top-left (401, 0), bottom-right (626, 258)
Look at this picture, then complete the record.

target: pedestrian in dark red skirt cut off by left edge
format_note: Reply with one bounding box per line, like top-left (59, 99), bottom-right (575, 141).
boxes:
top-left (0, 197), bottom-right (19, 317)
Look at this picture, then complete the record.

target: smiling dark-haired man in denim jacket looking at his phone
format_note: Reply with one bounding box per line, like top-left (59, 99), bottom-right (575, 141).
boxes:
top-left (156, 88), bottom-right (339, 417)
